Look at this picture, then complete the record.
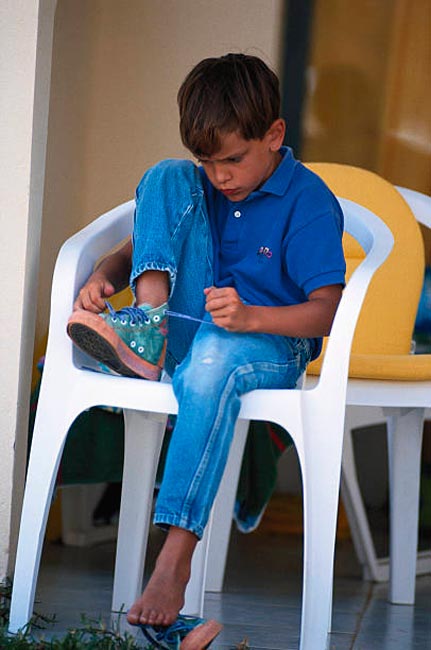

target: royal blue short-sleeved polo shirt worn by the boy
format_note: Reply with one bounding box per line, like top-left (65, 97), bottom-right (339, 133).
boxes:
top-left (200, 147), bottom-right (346, 356)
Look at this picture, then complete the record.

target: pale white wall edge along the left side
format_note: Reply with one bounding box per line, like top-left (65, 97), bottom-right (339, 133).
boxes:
top-left (0, 0), bottom-right (55, 579)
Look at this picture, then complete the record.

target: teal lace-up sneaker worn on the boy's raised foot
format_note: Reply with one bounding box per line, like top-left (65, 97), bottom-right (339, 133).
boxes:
top-left (67, 303), bottom-right (168, 381)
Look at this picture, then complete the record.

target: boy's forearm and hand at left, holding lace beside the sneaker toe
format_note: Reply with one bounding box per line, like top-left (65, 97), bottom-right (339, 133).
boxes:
top-left (73, 239), bottom-right (132, 314)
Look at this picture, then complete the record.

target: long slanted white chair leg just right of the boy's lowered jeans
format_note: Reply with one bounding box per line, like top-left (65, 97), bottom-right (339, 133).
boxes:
top-left (205, 420), bottom-right (249, 592)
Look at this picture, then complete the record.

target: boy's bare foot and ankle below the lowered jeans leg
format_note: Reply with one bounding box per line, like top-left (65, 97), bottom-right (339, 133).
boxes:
top-left (127, 526), bottom-right (198, 626)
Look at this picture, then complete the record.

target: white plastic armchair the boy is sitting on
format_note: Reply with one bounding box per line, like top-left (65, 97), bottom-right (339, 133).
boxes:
top-left (9, 200), bottom-right (393, 650)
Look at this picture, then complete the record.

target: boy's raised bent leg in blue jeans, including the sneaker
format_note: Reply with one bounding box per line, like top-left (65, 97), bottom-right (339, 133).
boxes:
top-left (68, 160), bottom-right (212, 379)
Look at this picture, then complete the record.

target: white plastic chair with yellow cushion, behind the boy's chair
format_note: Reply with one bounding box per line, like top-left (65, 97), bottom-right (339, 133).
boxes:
top-left (206, 163), bottom-right (431, 604)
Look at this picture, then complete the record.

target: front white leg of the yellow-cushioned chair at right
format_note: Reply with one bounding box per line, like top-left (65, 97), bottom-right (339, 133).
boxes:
top-left (386, 408), bottom-right (424, 605)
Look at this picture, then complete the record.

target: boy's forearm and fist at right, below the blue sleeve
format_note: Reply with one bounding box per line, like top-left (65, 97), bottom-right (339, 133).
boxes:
top-left (205, 284), bottom-right (343, 338)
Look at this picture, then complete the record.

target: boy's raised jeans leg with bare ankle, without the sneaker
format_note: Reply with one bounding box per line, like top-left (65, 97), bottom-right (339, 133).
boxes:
top-left (130, 160), bottom-right (212, 374)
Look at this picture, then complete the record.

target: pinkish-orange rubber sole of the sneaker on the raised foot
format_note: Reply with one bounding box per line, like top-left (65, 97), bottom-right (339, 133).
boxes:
top-left (67, 310), bottom-right (166, 381)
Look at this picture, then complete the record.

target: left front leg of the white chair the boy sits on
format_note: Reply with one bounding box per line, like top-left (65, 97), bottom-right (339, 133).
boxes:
top-left (9, 402), bottom-right (77, 633)
